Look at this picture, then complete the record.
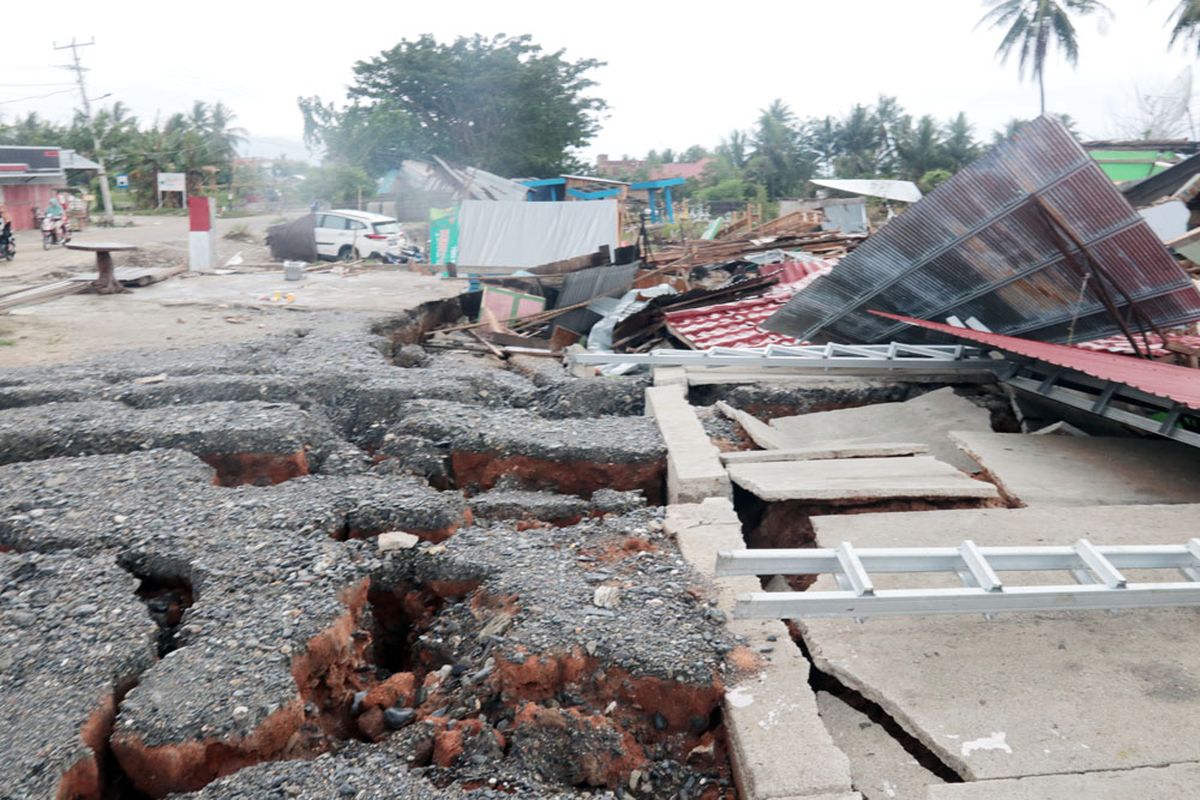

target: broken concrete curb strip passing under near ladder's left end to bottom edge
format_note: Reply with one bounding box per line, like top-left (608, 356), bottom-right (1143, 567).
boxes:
top-left (664, 499), bottom-right (858, 800)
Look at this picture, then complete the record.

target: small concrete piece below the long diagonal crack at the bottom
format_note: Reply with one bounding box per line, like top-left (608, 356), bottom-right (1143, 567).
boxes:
top-left (817, 692), bottom-right (943, 800)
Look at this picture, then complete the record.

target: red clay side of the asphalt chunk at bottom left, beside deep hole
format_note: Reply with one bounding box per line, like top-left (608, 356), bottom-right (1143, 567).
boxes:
top-left (112, 581), bottom-right (370, 798)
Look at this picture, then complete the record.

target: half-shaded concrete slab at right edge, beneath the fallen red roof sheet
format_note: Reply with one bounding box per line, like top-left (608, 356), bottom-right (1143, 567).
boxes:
top-left (952, 431), bottom-right (1200, 506)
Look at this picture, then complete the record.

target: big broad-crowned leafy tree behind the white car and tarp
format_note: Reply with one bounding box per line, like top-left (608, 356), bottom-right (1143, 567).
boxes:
top-left (300, 35), bottom-right (606, 175)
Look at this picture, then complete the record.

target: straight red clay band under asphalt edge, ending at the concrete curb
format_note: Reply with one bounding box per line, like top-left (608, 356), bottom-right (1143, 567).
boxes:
top-left (450, 452), bottom-right (666, 505)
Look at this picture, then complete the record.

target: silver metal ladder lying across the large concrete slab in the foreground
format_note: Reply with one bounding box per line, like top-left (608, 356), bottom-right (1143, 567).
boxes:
top-left (716, 539), bottom-right (1200, 620)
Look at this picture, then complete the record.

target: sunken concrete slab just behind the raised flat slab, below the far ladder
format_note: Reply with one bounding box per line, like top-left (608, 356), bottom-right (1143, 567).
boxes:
top-left (770, 387), bottom-right (991, 473)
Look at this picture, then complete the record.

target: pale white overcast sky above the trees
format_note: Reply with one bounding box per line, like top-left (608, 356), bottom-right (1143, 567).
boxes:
top-left (0, 0), bottom-right (1195, 164)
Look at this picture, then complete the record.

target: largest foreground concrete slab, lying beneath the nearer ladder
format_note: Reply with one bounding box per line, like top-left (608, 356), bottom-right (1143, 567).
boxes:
top-left (798, 505), bottom-right (1200, 782)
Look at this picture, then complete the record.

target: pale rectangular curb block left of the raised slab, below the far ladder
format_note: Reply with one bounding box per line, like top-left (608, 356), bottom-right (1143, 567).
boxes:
top-left (646, 384), bottom-right (733, 504)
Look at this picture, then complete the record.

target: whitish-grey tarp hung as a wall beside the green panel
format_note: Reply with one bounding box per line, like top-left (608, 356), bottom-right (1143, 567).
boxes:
top-left (458, 200), bottom-right (618, 269)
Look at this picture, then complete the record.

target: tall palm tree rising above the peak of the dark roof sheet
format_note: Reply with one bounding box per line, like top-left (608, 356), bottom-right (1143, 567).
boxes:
top-left (976, 0), bottom-right (1108, 115)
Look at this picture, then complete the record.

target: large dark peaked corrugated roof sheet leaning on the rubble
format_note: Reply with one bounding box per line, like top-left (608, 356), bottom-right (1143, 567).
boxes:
top-left (763, 118), bottom-right (1200, 343)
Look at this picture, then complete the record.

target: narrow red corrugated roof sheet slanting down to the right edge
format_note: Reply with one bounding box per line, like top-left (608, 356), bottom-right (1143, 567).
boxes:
top-left (872, 312), bottom-right (1200, 410)
